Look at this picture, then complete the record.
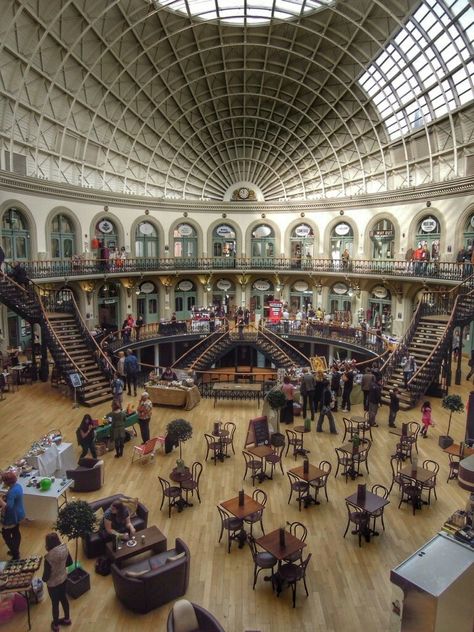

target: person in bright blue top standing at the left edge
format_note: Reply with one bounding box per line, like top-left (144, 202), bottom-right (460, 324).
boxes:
top-left (0, 470), bottom-right (25, 560)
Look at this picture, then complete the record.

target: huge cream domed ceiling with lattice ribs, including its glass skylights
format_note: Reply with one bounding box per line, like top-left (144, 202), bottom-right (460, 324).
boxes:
top-left (0, 0), bottom-right (474, 201)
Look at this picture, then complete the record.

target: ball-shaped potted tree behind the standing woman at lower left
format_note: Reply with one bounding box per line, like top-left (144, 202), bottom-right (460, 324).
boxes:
top-left (55, 500), bottom-right (96, 599)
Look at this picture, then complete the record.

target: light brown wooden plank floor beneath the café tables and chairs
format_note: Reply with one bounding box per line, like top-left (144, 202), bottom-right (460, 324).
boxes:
top-left (0, 370), bottom-right (471, 632)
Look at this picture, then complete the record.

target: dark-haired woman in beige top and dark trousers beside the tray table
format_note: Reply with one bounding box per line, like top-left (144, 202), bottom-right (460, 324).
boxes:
top-left (43, 532), bottom-right (73, 632)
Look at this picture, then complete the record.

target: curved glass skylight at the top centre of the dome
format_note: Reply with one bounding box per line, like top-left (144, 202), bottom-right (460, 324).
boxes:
top-left (152, 0), bottom-right (334, 25)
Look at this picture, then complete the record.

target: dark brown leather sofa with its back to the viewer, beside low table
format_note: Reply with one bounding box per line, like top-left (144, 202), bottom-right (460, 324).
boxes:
top-left (111, 538), bottom-right (191, 614)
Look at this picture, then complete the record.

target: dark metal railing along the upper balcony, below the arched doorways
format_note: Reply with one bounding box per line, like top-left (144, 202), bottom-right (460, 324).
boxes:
top-left (14, 257), bottom-right (473, 281)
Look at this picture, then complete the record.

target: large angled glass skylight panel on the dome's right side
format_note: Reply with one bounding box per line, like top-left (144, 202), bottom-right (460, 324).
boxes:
top-left (359, 0), bottom-right (474, 140)
